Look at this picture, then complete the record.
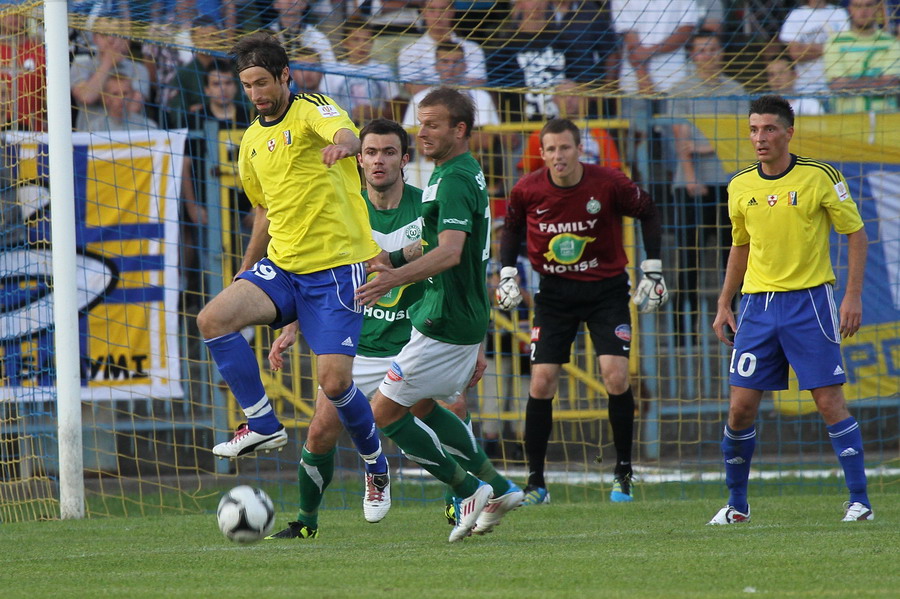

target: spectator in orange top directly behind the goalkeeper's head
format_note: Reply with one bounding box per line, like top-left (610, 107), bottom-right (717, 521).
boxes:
top-left (518, 79), bottom-right (623, 174)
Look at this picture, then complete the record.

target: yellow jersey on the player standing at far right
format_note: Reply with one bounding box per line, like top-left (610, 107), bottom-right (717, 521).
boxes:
top-left (728, 154), bottom-right (863, 293)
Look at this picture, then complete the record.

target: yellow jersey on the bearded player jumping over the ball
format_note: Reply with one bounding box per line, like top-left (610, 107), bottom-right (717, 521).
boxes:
top-left (238, 94), bottom-right (380, 274)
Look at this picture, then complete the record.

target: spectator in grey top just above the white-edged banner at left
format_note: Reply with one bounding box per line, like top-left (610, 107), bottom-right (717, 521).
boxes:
top-left (75, 73), bottom-right (158, 134)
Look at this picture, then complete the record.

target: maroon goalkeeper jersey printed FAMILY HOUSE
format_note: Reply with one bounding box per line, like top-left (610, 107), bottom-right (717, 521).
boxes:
top-left (504, 164), bottom-right (656, 281)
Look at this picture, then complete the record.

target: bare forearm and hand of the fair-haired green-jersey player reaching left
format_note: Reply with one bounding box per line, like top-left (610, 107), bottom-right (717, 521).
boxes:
top-left (356, 229), bottom-right (469, 306)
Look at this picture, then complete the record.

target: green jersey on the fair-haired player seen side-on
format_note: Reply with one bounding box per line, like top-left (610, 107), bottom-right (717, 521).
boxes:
top-left (410, 152), bottom-right (491, 345)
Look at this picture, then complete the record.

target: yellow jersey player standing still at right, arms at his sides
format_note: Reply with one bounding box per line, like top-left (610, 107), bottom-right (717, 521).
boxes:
top-left (709, 96), bottom-right (874, 524)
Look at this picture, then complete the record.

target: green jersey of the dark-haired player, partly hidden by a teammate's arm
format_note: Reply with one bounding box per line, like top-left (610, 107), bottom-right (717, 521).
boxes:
top-left (358, 185), bottom-right (422, 358)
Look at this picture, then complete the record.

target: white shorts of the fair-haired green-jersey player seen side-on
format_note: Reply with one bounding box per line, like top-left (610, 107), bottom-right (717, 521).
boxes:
top-left (378, 328), bottom-right (481, 408)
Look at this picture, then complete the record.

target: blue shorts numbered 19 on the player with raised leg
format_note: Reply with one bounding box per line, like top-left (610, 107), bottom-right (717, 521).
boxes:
top-left (238, 258), bottom-right (366, 356)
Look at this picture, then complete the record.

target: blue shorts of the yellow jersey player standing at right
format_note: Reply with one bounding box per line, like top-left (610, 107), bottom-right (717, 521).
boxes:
top-left (728, 284), bottom-right (847, 391)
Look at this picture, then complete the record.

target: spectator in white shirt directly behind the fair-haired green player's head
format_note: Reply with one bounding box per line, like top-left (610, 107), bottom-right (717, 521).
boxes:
top-left (401, 42), bottom-right (500, 188)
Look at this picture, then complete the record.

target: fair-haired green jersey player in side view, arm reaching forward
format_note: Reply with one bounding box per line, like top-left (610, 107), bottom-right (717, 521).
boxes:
top-left (357, 88), bottom-right (523, 542)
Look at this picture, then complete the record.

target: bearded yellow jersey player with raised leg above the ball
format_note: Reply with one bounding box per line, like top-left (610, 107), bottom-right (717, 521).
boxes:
top-left (197, 32), bottom-right (388, 524)
